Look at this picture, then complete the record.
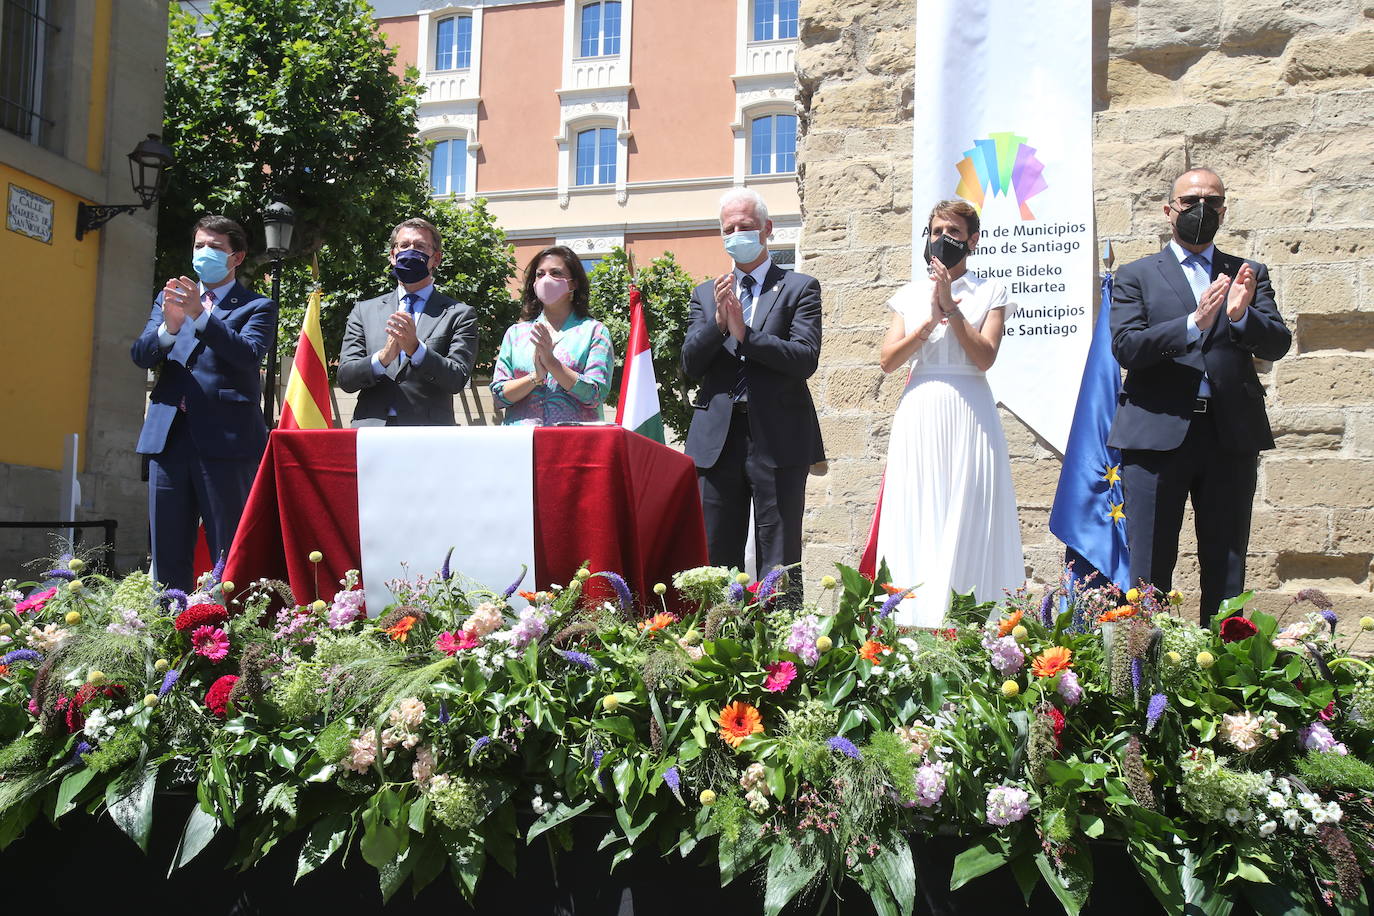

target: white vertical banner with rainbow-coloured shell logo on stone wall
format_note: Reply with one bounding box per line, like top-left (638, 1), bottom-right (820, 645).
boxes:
top-left (911, 0), bottom-right (1094, 453)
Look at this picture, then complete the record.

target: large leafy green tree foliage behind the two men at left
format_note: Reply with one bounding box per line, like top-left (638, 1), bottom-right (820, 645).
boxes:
top-left (158, 0), bottom-right (514, 365)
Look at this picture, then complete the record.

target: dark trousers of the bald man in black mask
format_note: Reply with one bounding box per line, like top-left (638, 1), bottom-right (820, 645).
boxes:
top-left (1121, 413), bottom-right (1259, 623)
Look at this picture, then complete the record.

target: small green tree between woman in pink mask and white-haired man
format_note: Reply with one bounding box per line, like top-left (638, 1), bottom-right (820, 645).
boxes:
top-left (587, 249), bottom-right (697, 441)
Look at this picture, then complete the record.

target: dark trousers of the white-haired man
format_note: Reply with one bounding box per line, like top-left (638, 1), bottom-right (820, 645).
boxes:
top-left (697, 411), bottom-right (809, 597)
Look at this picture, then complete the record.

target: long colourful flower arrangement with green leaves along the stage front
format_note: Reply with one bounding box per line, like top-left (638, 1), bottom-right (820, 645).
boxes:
top-left (0, 560), bottom-right (1374, 913)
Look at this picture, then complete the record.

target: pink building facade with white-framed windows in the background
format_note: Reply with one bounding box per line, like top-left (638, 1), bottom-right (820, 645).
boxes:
top-left (372, 0), bottom-right (801, 277)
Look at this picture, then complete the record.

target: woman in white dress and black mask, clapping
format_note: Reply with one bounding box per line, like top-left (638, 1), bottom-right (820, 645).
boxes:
top-left (878, 201), bottom-right (1025, 626)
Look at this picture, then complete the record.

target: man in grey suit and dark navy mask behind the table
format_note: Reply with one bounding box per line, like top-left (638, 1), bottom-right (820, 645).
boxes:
top-left (338, 218), bottom-right (477, 426)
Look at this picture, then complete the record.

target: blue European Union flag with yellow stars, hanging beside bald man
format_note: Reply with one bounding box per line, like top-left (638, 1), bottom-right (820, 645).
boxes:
top-left (1050, 273), bottom-right (1131, 588)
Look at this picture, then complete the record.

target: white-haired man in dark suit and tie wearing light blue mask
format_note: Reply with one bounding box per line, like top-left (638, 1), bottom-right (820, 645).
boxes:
top-left (683, 188), bottom-right (824, 587)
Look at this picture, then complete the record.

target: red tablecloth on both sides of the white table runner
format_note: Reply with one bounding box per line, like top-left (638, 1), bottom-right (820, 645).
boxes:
top-left (224, 426), bottom-right (706, 611)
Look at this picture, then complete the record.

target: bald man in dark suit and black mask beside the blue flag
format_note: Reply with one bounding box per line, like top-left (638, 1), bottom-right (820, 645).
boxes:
top-left (1107, 169), bottom-right (1292, 622)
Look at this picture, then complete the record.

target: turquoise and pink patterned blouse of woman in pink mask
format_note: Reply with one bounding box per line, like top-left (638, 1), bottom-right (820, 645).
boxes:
top-left (492, 314), bottom-right (614, 426)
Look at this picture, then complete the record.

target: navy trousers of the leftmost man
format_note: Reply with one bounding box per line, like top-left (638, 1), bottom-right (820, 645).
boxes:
top-left (148, 416), bottom-right (258, 592)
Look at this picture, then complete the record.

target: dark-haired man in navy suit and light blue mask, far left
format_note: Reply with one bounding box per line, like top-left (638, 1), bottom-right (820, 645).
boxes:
top-left (131, 216), bottom-right (278, 591)
